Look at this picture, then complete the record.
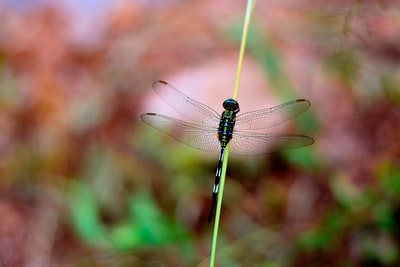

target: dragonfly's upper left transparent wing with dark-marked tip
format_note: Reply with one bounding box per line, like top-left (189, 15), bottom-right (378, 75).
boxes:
top-left (153, 81), bottom-right (220, 126)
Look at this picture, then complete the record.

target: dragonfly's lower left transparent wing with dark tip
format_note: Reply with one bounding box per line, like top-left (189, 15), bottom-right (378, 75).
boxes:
top-left (140, 113), bottom-right (220, 152)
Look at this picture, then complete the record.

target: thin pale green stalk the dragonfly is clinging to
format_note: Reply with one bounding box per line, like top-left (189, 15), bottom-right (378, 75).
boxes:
top-left (210, 0), bottom-right (256, 267)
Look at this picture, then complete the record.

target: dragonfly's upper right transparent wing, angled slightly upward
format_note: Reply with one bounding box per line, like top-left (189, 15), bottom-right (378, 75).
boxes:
top-left (235, 99), bottom-right (310, 130)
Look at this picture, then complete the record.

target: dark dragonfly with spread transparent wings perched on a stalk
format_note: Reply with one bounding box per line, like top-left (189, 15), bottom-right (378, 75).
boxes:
top-left (140, 80), bottom-right (314, 223)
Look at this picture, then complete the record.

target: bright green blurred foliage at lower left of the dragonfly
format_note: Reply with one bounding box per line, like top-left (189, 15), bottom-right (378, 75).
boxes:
top-left (71, 183), bottom-right (188, 251)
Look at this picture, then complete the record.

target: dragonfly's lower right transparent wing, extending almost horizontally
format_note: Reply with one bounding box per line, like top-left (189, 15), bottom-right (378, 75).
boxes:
top-left (231, 131), bottom-right (314, 156)
